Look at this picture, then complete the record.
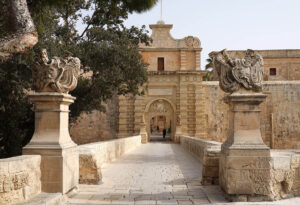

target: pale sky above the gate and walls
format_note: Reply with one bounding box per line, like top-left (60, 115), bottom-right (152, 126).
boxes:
top-left (125, 0), bottom-right (300, 68)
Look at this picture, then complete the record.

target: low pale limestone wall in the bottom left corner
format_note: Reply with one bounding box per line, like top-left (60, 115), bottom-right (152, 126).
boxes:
top-left (0, 155), bottom-right (41, 205)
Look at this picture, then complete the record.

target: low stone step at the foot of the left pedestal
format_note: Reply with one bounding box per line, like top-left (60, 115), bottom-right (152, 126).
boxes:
top-left (16, 192), bottom-right (64, 205)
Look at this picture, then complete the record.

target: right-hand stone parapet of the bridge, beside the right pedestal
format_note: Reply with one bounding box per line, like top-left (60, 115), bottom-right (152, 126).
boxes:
top-left (180, 136), bottom-right (222, 185)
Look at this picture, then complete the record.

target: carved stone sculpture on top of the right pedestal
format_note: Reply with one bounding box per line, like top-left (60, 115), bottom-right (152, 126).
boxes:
top-left (209, 49), bottom-right (264, 93)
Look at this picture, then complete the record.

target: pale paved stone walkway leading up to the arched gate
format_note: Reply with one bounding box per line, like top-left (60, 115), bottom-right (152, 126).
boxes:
top-left (67, 142), bottom-right (226, 205)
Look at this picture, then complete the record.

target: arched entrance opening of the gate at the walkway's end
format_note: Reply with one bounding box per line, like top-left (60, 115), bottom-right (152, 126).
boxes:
top-left (145, 98), bottom-right (176, 140)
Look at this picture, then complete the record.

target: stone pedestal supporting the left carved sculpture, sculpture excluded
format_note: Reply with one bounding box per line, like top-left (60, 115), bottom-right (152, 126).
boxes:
top-left (23, 92), bottom-right (79, 194)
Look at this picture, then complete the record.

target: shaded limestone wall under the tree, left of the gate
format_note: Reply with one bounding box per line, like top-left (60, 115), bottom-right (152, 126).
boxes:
top-left (70, 96), bottom-right (119, 145)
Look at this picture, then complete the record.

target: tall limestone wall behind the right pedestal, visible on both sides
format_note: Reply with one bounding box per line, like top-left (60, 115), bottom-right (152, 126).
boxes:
top-left (203, 81), bottom-right (300, 149)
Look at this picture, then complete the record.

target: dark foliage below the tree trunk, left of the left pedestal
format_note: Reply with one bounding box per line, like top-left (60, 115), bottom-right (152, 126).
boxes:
top-left (0, 56), bottom-right (34, 158)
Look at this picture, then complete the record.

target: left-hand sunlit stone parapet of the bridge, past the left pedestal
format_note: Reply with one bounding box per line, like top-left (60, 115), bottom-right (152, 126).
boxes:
top-left (78, 135), bottom-right (141, 184)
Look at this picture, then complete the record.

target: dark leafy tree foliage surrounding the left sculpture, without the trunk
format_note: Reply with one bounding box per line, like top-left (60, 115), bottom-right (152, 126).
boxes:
top-left (0, 0), bottom-right (156, 157)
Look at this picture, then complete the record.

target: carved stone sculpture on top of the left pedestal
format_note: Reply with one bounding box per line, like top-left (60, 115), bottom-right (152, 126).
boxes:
top-left (32, 49), bottom-right (80, 93)
